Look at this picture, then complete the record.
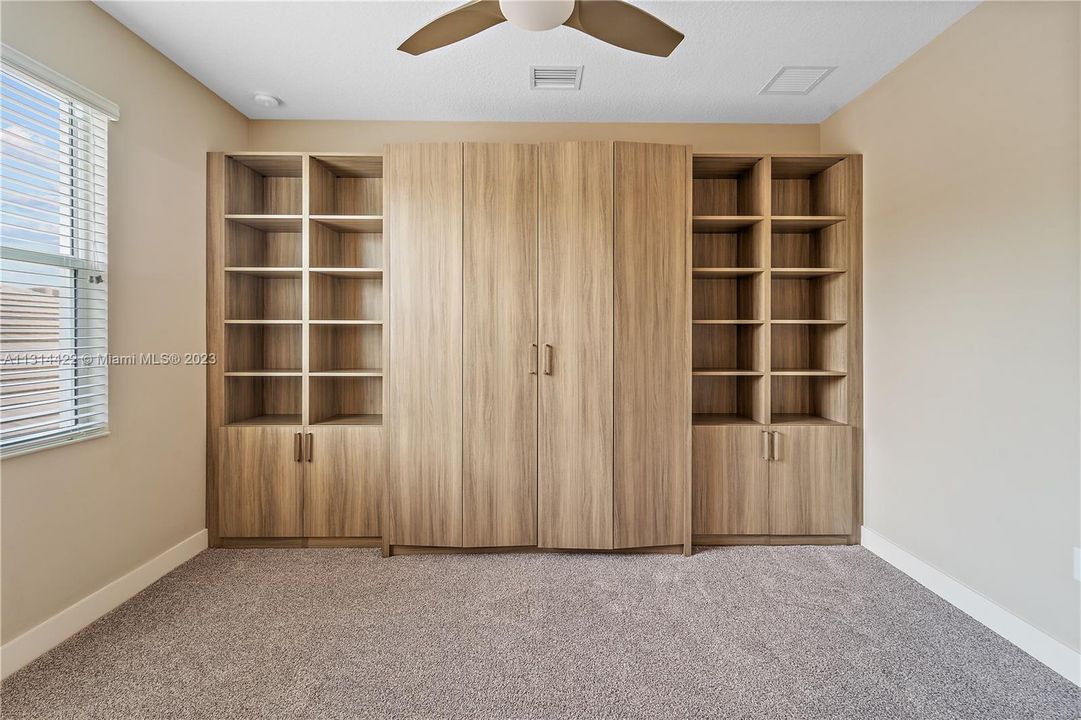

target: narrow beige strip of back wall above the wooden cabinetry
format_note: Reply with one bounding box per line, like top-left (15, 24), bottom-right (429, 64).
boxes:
top-left (247, 120), bottom-right (818, 152)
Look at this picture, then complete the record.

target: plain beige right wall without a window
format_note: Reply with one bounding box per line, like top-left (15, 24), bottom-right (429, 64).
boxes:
top-left (822, 2), bottom-right (1081, 650)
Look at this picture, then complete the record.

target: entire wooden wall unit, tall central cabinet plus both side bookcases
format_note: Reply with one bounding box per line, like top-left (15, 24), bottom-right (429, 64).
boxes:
top-left (206, 142), bottom-right (863, 554)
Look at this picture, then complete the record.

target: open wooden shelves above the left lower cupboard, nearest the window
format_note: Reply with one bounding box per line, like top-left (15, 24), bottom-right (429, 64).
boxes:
top-left (212, 152), bottom-right (386, 427)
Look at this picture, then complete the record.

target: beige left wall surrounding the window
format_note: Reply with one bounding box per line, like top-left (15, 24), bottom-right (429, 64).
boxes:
top-left (0, 0), bottom-right (248, 642)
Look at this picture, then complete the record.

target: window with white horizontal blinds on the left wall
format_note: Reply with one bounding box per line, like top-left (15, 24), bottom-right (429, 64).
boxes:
top-left (0, 46), bottom-right (117, 456)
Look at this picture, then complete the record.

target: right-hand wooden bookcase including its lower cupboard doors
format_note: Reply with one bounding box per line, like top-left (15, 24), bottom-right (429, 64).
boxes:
top-left (691, 155), bottom-right (863, 544)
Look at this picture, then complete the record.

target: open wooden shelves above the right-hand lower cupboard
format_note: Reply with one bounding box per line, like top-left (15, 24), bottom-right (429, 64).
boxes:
top-left (691, 155), bottom-right (859, 426)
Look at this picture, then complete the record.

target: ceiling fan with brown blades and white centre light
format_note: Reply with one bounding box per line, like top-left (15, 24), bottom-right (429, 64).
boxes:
top-left (398, 0), bottom-right (683, 57)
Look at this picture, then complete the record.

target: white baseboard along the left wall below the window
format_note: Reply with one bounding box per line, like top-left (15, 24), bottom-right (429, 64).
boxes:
top-left (0, 530), bottom-right (206, 678)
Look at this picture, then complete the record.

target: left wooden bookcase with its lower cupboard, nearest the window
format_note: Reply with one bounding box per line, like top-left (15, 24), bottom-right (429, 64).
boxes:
top-left (206, 152), bottom-right (386, 545)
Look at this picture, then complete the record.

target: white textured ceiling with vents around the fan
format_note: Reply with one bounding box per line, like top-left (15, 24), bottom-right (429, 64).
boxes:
top-left (97, 0), bottom-right (977, 123)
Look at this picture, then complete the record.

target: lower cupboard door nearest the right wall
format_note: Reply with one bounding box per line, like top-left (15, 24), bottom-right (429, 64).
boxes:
top-left (770, 426), bottom-right (852, 535)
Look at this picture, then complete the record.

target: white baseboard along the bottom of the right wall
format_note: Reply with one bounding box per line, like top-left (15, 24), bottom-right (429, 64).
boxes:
top-left (860, 525), bottom-right (1081, 685)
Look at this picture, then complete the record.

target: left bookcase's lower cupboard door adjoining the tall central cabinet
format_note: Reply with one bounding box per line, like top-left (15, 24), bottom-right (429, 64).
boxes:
top-left (303, 426), bottom-right (383, 537)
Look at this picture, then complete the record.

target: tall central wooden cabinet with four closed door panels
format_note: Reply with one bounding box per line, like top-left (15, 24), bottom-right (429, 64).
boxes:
top-left (384, 142), bottom-right (690, 551)
